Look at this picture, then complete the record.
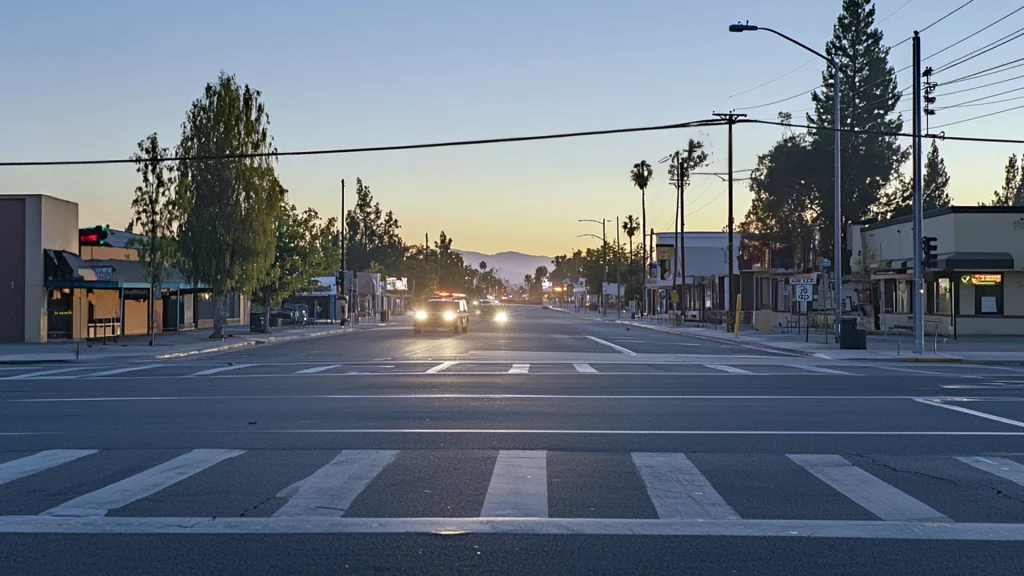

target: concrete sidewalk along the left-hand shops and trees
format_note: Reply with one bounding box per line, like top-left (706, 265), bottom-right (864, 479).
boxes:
top-left (0, 317), bottom-right (401, 364)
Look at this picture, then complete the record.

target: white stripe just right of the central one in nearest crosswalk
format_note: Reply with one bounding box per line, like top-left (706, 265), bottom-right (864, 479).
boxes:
top-left (633, 452), bottom-right (739, 520)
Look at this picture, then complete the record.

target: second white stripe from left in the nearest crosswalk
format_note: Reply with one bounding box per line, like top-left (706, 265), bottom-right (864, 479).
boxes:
top-left (40, 449), bottom-right (245, 517)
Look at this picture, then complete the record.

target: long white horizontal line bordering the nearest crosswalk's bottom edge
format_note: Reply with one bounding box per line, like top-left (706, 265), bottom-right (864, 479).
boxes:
top-left (6, 516), bottom-right (1024, 542)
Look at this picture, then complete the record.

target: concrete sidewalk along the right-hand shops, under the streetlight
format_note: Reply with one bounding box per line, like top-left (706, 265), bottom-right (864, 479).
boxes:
top-left (565, 311), bottom-right (1024, 364)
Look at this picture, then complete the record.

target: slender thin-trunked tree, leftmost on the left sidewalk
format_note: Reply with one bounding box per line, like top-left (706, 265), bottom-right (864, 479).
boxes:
top-left (128, 133), bottom-right (177, 346)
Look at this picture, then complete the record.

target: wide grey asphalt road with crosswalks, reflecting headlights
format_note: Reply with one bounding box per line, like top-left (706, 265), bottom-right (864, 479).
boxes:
top-left (0, 306), bottom-right (1024, 576)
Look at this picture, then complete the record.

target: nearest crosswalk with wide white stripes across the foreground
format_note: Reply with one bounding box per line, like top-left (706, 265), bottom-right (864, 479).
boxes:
top-left (0, 448), bottom-right (1024, 540)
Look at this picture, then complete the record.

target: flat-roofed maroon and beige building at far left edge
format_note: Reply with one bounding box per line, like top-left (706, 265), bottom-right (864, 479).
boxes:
top-left (0, 194), bottom-right (78, 342)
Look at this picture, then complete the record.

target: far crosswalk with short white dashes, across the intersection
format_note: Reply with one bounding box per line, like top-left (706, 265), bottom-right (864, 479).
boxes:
top-left (0, 357), bottom-right (1007, 379)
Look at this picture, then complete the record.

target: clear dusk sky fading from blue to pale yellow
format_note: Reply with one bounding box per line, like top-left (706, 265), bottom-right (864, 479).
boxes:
top-left (0, 0), bottom-right (1024, 255)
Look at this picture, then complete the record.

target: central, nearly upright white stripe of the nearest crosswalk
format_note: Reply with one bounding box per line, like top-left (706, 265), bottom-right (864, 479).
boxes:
top-left (480, 450), bottom-right (548, 518)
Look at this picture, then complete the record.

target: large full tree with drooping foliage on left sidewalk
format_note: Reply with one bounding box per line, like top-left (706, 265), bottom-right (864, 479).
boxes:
top-left (176, 72), bottom-right (282, 338)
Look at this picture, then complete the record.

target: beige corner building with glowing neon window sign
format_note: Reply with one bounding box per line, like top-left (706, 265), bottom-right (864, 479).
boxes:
top-left (849, 206), bottom-right (1024, 336)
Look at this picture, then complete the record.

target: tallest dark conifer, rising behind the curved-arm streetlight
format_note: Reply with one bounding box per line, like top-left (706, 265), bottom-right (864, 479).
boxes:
top-left (806, 0), bottom-right (909, 248)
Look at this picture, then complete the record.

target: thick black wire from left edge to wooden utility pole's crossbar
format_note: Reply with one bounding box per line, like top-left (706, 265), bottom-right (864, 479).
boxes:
top-left (0, 118), bottom-right (727, 168)
